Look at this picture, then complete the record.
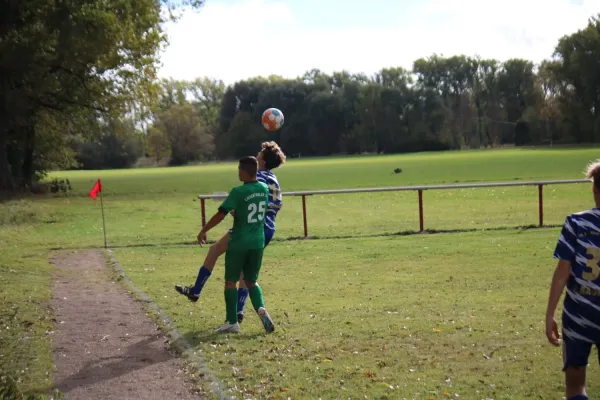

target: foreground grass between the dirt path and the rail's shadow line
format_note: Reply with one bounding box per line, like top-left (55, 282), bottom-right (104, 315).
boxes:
top-left (116, 229), bottom-right (600, 399)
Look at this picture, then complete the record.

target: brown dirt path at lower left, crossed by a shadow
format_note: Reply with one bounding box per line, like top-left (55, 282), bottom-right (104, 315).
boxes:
top-left (51, 250), bottom-right (198, 400)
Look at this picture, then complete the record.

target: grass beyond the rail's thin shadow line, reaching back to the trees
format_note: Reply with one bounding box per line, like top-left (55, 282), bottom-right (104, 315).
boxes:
top-left (35, 149), bottom-right (600, 247)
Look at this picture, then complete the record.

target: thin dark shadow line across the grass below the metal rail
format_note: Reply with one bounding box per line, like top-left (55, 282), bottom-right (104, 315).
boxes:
top-left (50, 225), bottom-right (562, 251)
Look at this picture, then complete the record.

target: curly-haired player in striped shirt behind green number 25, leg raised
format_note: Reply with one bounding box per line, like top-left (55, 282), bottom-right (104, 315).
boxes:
top-left (175, 142), bottom-right (285, 322)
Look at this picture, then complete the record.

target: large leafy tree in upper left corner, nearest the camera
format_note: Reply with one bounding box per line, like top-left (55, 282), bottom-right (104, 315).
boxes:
top-left (0, 0), bottom-right (201, 190)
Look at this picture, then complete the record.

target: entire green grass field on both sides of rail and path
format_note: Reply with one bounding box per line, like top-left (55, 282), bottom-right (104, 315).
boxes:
top-left (0, 149), bottom-right (600, 399)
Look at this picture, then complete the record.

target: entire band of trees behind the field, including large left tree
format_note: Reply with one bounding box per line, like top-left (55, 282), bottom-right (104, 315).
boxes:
top-left (0, 0), bottom-right (600, 189)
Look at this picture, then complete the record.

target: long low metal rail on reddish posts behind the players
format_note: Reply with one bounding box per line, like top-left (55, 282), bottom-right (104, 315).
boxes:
top-left (198, 179), bottom-right (590, 237)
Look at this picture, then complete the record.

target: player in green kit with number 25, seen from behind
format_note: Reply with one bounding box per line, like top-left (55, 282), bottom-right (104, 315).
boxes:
top-left (198, 157), bottom-right (275, 333)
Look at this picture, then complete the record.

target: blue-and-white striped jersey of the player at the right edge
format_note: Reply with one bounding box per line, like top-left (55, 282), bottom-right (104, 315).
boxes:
top-left (554, 208), bottom-right (600, 343)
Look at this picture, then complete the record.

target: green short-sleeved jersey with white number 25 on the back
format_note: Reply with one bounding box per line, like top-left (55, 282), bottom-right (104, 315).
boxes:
top-left (219, 182), bottom-right (269, 250)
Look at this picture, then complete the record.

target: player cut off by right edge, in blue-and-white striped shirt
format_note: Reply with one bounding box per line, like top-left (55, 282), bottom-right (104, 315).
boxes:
top-left (546, 161), bottom-right (600, 400)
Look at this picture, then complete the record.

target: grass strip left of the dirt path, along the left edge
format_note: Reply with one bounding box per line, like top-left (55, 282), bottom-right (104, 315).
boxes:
top-left (0, 201), bottom-right (52, 398)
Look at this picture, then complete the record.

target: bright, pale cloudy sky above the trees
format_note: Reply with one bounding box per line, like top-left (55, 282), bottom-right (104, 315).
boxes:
top-left (159, 0), bottom-right (600, 84)
